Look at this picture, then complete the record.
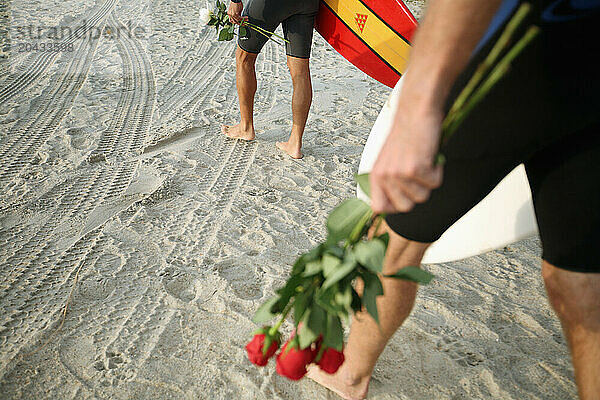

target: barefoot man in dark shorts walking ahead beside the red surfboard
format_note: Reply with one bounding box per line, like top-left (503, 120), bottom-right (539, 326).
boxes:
top-left (221, 0), bottom-right (319, 158)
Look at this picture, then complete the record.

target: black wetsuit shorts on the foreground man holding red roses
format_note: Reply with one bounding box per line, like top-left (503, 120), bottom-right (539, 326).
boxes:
top-left (387, 0), bottom-right (600, 272)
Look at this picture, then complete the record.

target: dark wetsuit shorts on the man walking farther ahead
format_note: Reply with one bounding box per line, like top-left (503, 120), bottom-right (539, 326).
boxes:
top-left (238, 0), bottom-right (319, 58)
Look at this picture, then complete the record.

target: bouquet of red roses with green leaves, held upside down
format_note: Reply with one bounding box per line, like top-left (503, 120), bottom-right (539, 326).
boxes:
top-left (246, 3), bottom-right (539, 380)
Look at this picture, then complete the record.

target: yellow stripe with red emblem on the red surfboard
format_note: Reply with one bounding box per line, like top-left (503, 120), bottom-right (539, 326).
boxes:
top-left (323, 0), bottom-right (410, 74)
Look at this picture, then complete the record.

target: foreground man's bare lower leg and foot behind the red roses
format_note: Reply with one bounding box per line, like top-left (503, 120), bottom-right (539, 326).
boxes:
top-left (307, 222), bottom-right (429, 399)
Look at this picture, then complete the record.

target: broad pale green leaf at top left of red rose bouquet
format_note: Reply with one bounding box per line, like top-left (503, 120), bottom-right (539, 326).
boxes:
top-left (327, 198), bottom-right (372, 243)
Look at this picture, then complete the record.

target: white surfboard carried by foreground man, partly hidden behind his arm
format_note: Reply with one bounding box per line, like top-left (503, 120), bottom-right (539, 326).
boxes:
top-left (357, 78), bottom-right (538, 264)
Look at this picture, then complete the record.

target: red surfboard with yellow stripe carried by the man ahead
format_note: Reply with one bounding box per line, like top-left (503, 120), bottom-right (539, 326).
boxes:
top-left (315, 0), bottom-right (417, 87)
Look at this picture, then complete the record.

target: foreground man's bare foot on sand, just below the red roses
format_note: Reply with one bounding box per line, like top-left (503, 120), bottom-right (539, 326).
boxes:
top-left (306, 365), bottom-right (370, 400)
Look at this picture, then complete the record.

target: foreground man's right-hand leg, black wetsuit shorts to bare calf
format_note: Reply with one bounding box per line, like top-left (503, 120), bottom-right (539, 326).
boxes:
top-left (525, 124), bottom-right (600, 400)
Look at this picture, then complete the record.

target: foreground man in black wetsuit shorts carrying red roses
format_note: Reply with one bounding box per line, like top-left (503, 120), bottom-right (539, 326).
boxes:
top-left (308, 0), bottom-right (600, 400)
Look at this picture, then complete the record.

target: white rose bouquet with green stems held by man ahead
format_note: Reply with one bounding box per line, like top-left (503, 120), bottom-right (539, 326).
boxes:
top-left (200, 0), bottom-right (288, 44)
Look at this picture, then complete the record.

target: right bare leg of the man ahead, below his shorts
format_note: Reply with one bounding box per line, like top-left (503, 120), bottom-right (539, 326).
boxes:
top-left (276, 56), bottom-right (312, 158)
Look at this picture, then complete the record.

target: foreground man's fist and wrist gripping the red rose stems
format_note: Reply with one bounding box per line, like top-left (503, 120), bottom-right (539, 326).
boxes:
top-left (370, 102), bottom-right (443, 214)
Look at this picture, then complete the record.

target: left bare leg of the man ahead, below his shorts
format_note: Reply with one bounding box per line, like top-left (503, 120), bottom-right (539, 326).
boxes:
top-left (221, 46), bottom-right (258, 140)
